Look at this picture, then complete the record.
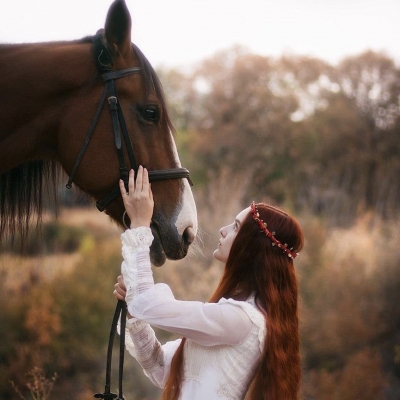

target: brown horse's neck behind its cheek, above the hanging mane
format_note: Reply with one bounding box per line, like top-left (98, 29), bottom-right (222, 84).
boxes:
top-left (0, 42), bottom-right (95, 173)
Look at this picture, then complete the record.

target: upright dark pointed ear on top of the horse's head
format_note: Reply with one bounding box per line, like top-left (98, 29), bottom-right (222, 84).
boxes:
top-left (105, 0), bottom-right (132, 55)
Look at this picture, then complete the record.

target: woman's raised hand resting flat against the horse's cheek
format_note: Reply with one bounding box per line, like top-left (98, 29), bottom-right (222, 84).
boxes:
top-left (119, 166), bottom-right (154, 229)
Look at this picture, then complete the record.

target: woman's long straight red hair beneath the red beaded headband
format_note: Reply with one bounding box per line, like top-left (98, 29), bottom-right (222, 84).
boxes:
top-left (162, 203), bottom-right (304, 400)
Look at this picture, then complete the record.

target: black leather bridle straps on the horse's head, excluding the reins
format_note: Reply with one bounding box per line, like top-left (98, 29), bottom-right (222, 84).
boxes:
top-left (66, 33), bottom-right (193, 211)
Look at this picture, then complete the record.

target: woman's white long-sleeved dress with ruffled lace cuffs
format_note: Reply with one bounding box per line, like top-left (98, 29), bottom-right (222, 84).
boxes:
top-left (121, 227), bottom-right (266, 400)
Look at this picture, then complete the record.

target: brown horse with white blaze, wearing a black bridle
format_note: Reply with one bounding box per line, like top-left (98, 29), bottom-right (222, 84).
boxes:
top-left (0, 0), bottom-right (197, 265)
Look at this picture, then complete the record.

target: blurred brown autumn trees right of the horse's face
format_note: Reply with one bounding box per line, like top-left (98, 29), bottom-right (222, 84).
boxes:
top-left (164, 48), bottom-right (400, 225)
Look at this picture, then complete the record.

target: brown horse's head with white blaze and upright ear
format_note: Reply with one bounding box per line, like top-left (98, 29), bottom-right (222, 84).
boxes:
top-left (62, 0), bottom-right (197, 265)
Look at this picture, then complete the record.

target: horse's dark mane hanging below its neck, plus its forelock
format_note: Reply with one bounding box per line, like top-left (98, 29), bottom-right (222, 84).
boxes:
top-left (0, 36), bottom-right (175, 246)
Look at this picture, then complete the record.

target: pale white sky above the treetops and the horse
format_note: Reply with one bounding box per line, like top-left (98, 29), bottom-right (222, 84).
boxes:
top-left (0, 0), bottom-right (400, 67)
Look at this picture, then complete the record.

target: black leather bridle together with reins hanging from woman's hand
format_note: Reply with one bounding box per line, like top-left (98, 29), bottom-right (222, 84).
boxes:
top-left (66, 31), bottom-right (192, 400)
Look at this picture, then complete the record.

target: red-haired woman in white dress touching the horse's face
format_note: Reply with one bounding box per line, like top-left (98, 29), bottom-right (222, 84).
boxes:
top-left (114, 167), bottom-right (303, 400)
